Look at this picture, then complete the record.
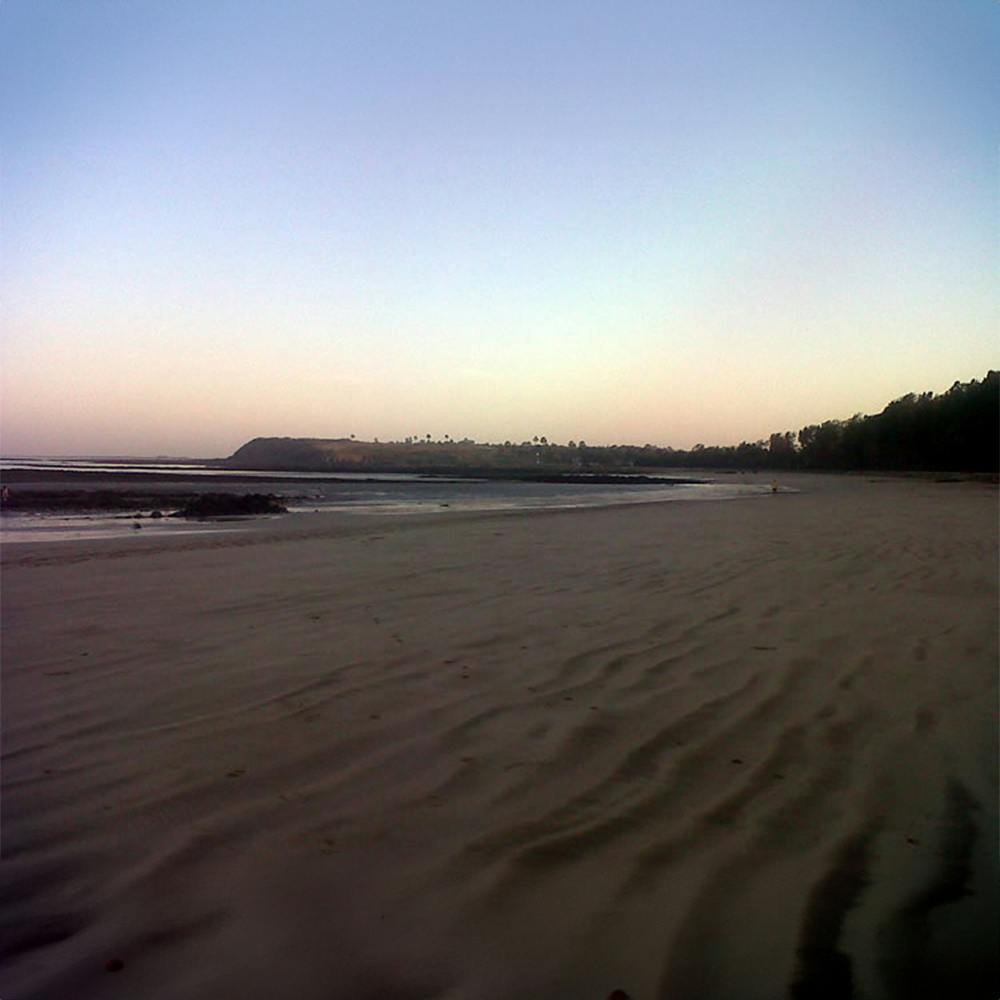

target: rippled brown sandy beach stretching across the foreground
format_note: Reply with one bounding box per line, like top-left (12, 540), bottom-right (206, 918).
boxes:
top-left (0, 477), bottom-right (1000, 1000)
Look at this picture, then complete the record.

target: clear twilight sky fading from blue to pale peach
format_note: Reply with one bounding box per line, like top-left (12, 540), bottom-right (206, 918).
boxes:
top-left (0, 0), bottom-right (1000, 457)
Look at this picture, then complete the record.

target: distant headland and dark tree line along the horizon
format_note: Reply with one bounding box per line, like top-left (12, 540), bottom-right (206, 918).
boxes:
top-left (218, 371), bottom-right (1000, 480)
